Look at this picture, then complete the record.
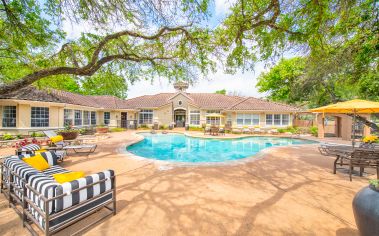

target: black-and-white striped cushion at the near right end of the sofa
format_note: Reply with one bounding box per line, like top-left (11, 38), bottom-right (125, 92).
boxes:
top-left (55, 170), bottom-right (114, 212)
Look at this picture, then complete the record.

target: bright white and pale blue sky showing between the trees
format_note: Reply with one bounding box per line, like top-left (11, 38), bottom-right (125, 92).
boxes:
top-left (63, 0), bottom-right (264, 98)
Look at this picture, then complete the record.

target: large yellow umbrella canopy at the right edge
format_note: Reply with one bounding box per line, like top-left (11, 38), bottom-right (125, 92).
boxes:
top-left (309, 99), bottom-right (379, 114)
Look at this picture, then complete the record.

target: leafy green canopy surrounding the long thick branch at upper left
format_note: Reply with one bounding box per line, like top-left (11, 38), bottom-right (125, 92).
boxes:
top-left (0, 0), bottom-right (214, 98)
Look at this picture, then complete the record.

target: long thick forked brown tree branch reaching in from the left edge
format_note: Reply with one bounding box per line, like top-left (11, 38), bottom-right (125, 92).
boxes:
top-left (0, 26), bottom-right (192, 94)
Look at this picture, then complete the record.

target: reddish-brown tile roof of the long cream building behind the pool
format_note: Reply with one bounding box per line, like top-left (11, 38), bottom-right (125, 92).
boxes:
top-left (0, 86), bottom-right (300, 112)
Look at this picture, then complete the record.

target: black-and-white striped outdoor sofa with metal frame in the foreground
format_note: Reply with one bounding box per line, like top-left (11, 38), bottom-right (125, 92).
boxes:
top-left (1, 153), bottom-right (116, 235)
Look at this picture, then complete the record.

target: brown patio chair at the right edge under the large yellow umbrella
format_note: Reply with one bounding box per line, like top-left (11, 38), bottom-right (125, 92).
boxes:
top-left (345, 148), bottom-right (379, 181)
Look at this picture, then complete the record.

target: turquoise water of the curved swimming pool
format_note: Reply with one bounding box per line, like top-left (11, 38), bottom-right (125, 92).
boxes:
top-left (127, 133), bottom-right (316, 163)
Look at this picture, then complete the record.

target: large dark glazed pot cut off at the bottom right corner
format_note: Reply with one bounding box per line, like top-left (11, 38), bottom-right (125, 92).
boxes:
top-left (353, 179), bottom-right (379, 236)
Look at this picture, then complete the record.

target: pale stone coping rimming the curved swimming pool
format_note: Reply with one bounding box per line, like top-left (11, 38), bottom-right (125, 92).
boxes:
top-left (118, 130), bottom-right (319, 170)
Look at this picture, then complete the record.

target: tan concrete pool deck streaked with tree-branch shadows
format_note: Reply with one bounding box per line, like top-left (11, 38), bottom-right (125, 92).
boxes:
top-left (0, 131), bottom-right (376, 236)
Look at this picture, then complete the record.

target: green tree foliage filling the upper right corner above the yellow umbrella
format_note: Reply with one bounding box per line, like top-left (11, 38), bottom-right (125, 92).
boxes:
top-left (221, 0), bottom-right (379, 107)
